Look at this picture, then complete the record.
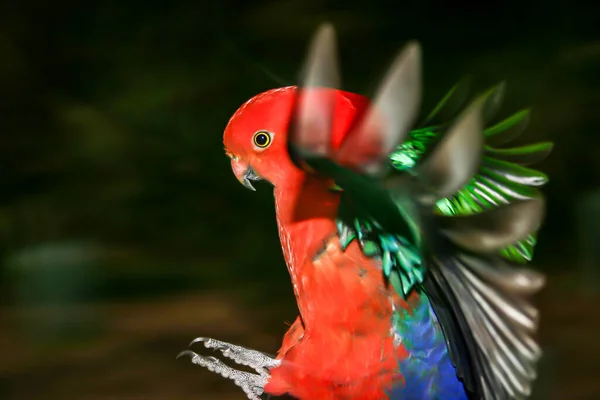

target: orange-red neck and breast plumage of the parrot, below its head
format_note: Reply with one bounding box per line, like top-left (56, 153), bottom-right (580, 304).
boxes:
top-left (265, 170), bottom-right (408, 399)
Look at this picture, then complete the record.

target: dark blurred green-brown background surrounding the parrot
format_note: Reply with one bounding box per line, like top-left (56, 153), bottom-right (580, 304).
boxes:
top-left (0, 0), bottom-right (600, 400)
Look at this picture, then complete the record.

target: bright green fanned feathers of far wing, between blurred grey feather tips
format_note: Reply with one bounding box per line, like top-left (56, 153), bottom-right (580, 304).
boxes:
top-left (390, 81), bottom-right (552, 264)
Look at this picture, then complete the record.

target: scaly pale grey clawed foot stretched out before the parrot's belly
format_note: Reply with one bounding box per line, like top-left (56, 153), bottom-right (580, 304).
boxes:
top-left (177, 337), bottom-right (281, 400)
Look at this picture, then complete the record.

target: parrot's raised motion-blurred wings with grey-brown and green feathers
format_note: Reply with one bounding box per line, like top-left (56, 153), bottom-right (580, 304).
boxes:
top-left (288, 25), bottom-right (551, 399)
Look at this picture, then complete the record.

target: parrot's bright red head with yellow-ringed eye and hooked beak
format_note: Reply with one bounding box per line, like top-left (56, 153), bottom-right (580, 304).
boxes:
top-left (223, 86), bottom-right (367, 190)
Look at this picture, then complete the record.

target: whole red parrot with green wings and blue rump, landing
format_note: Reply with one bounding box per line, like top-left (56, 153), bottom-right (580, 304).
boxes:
top-left (180, 23), bottom-right (552, 400)
